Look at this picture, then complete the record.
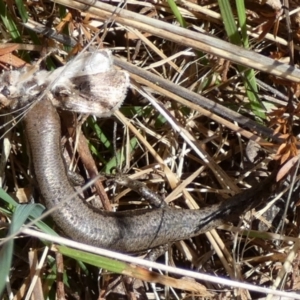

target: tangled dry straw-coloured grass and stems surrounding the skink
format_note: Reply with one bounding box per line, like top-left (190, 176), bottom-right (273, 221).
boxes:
top-left (0, 0), bottom-right (300, 299)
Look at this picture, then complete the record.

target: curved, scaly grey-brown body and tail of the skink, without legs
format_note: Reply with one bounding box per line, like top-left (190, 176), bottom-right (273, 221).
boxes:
top-left (25, 97), bottom-right (274, 252)
